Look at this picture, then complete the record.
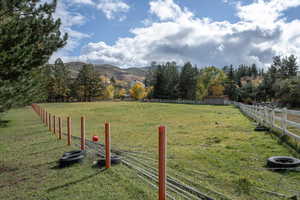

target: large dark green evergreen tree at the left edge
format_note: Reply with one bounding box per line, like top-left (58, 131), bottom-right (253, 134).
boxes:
top-left (0, 0), bottom-right (67, 111)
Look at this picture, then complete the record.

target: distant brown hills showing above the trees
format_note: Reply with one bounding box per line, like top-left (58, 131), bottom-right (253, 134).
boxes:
top-left (65, 62), bottom-right (148, 82)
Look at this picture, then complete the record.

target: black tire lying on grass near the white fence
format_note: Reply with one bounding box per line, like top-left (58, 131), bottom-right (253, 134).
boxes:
top-left (267, 156), bottom-right (300, 168)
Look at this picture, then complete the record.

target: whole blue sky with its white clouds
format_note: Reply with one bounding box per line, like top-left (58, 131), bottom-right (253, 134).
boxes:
top-left (50, 0), bottom-right (300, 67)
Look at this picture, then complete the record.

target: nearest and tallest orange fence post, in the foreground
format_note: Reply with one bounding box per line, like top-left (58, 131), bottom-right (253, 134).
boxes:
top-left (158, 126), bottom-right (167, 200)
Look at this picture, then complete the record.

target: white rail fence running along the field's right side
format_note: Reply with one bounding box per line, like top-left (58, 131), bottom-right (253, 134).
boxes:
top-left (233, 102), bottom-right (300, 142)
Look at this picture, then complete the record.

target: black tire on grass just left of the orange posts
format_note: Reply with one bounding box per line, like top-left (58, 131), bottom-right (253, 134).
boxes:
top-left (59, 150), bottom-right (85, 167)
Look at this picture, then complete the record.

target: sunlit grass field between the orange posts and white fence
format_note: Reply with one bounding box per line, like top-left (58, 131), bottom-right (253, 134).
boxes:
top-left (40, 102), bottom-right (300, 199)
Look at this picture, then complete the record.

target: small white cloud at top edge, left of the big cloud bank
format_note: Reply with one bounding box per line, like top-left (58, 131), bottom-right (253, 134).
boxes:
top-left (96, 0), bottom-right (130, 21)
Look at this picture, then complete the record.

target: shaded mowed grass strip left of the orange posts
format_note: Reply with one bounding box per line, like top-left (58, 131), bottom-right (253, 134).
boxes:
top-left (0, 107), bottom-right (157, 200)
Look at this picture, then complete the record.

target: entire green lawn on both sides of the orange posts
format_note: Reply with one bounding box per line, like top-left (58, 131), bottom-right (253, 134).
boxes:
top-left (0, 102), bottom-right (300, 200)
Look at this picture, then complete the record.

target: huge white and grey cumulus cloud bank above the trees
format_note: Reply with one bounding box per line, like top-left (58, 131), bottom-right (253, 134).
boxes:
top-left (60, 0), bottom-right (300, 67)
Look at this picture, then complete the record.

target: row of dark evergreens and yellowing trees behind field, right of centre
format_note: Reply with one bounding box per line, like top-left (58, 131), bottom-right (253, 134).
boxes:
top-left (145, 55), bottom-right (300, 106)
